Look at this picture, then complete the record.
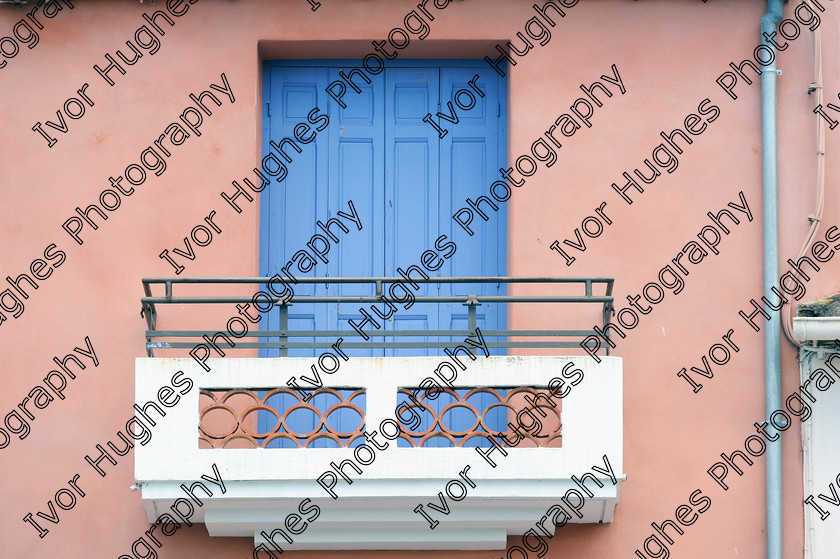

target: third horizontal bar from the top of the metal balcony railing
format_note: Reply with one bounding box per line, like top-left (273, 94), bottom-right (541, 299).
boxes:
top-left (146, 330), bottom-right (595, 338)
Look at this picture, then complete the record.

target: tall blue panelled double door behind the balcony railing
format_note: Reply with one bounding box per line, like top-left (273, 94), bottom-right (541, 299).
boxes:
top-left (260, 60), bottom-right (506, 446)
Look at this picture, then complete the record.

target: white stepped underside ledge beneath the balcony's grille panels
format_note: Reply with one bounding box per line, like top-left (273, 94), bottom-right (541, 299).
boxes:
top-left (143, 479), bottom-right (620, 549)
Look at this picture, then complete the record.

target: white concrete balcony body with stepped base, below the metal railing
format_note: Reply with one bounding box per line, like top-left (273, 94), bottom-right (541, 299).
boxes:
top-left (135, 356), bottom-right (624, 557)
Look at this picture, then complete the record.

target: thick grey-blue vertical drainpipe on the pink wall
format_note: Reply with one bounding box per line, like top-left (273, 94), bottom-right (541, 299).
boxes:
top-left (761, 0), bottom-right (783, 559)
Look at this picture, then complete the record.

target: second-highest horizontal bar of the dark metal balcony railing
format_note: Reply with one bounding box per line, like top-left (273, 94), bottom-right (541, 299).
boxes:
top-left (140, 295), bottom-right (613, 304)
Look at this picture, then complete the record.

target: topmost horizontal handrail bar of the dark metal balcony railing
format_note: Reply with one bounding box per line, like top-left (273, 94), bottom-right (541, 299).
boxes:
top-left (141, 276), bottom-right (615, 284)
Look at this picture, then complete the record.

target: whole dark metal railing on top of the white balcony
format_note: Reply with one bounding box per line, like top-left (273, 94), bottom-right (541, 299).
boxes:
top-left (140, 277), bottom-right (614, 357)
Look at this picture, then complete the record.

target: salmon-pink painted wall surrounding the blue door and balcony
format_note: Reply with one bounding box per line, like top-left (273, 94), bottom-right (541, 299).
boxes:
top-left (0, 0), bottom-right (840, 559)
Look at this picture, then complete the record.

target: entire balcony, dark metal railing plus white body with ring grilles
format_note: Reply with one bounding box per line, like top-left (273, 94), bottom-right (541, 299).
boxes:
top-left (135, 278), bottom-right (624, 557)
